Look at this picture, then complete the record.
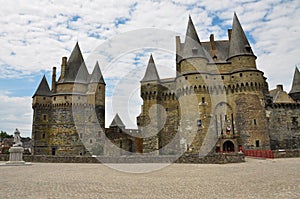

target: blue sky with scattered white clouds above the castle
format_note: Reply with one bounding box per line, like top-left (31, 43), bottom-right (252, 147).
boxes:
top-left (0, 0), bottom-right (300, 136)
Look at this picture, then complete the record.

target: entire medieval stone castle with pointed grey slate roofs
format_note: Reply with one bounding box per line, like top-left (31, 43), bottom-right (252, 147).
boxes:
top-left (32, 14), bottom-right (300, 155)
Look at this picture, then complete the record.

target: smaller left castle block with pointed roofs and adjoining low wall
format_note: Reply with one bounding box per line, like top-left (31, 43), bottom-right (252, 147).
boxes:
top-left (32, 43), bottom-right (137, 156)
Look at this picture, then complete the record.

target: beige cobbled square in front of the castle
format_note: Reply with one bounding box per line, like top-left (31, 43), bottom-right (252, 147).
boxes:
top-left (0, 158), bottom-right (300, 199)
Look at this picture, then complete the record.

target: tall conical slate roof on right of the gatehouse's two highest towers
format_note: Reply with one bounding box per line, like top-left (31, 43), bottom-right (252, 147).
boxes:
top-left (228, 13), bottom-right (255, 59)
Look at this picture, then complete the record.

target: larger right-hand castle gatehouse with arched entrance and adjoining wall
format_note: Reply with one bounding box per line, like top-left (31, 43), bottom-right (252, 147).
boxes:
top-left (138, 15), bottom-right (300, 155)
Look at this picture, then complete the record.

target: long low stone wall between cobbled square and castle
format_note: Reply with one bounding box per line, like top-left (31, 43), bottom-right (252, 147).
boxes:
top-left (0, 153), bottom-right (245, 164)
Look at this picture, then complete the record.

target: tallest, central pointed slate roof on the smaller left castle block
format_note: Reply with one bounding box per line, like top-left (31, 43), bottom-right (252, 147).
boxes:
top-left (61, 42), bottom-right (89, 83)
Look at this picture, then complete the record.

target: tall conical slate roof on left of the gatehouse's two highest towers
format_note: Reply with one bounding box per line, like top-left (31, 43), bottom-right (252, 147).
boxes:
top-left (180, 16), bottom-right (208, 59)
